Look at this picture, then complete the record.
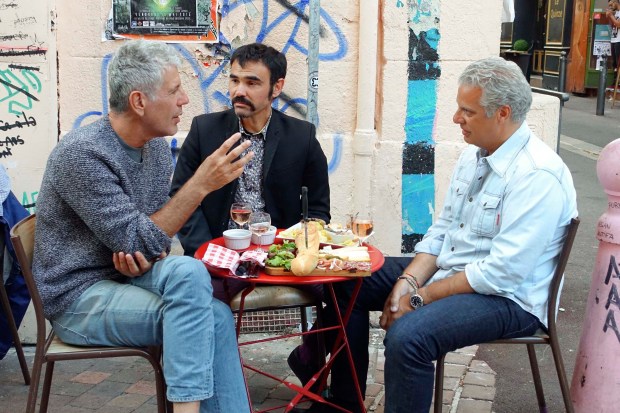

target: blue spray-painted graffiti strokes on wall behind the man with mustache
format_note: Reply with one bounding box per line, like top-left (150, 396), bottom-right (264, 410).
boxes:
top-left (73, 0), bottom-right (348, 171)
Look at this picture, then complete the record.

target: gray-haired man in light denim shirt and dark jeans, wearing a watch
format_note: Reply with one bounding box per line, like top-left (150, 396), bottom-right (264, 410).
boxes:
top-left (296, 57), bottom-right (577, 413)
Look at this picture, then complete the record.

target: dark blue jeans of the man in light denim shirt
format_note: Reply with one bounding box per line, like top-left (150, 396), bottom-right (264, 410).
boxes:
top-left (328, 258), bottom-right (541, 413)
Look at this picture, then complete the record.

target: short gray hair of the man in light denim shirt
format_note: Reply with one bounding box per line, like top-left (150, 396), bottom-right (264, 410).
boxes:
top-left (459, 57), bottom-right (532, 123)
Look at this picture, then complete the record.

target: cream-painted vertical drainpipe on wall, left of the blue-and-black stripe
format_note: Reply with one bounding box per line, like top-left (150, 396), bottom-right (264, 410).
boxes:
top-left (351, 0), bottom-right (379, 213)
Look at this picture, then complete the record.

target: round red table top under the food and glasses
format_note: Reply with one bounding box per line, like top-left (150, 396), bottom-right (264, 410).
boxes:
top-left (194, 237), bottom-right (385, 284)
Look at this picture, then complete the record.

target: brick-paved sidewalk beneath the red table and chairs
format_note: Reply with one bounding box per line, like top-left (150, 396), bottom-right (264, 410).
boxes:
top-left (0, 329), bottom-right (495, 413)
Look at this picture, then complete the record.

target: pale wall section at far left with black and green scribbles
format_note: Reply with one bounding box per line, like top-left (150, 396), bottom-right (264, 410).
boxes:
top-left (0, 0), bottom-right (58, 216)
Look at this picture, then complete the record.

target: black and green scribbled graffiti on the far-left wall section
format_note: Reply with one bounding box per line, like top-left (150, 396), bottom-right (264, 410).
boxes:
top-left (0, 0), bottom-right (49, 212)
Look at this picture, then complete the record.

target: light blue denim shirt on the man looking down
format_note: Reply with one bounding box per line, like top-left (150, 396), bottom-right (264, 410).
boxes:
top-left (415, 122), bottom-right (577, 326)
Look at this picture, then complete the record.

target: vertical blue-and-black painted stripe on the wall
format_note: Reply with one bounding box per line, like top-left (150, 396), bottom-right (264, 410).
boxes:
top-left (401, 0), bottom-right (441, 253)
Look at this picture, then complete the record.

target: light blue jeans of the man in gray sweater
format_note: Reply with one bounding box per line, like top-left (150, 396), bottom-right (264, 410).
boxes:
top-left (52, 256), bottom-right (250, 413)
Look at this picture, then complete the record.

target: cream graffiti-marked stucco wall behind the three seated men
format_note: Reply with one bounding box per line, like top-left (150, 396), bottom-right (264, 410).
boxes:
top-left (7, 0), bottom-right (557, 255)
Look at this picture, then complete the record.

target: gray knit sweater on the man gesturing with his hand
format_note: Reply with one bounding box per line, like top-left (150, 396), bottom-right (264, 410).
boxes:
top-left (33, 117), bottom-right (172, 319)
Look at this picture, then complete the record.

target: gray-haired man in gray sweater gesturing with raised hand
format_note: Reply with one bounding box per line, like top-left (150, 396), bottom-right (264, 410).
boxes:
top-left (33, 41), bottom-right (253, 413)
